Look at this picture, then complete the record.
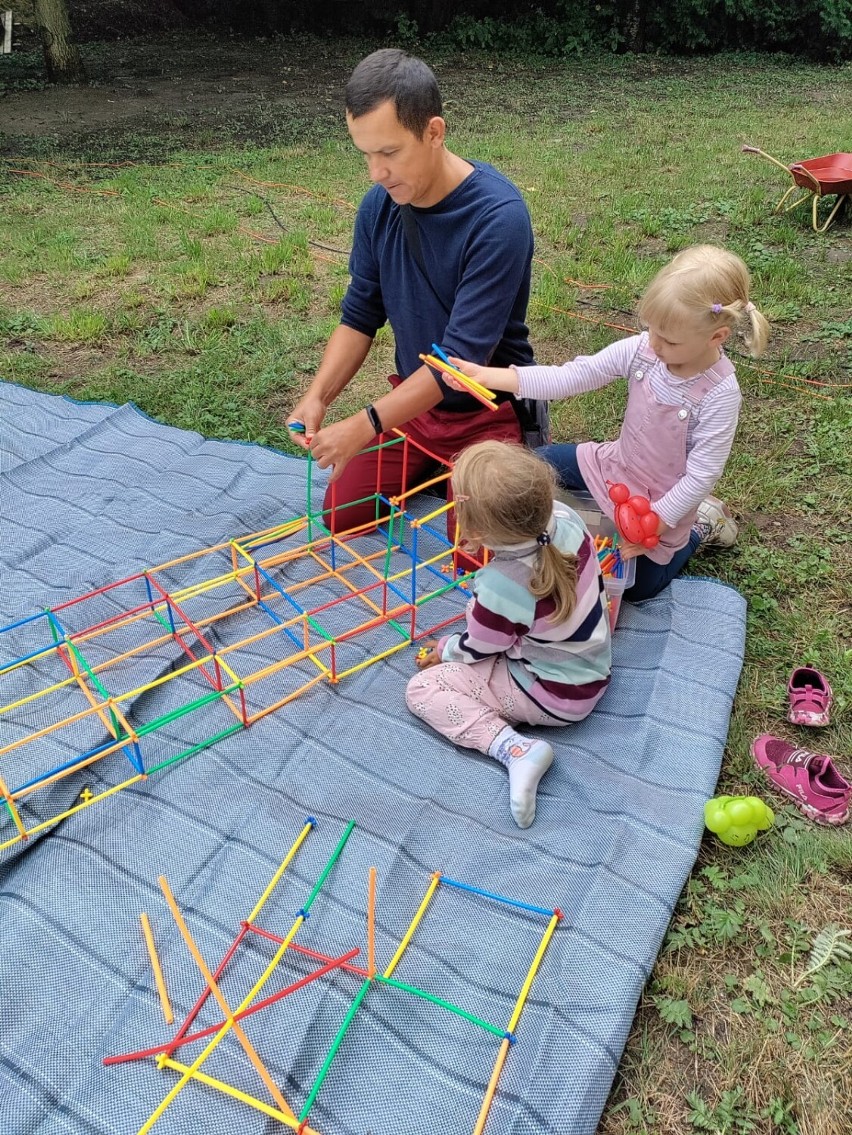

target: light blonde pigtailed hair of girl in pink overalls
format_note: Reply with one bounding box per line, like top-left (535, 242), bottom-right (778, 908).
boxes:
top-left (639, 244), bottom-right (769, 356)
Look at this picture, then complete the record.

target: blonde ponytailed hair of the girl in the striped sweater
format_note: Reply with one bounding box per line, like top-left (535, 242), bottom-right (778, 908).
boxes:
top-left (453, 442), bottom-right (577, 623)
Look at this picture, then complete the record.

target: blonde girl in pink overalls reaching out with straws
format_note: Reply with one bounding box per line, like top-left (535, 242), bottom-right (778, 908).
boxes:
top-left (447, 244), bottom-right (769, 600)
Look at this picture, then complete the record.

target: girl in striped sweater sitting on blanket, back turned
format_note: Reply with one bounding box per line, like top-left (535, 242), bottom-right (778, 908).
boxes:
top-left (406, 442), bottom-right (611, 827)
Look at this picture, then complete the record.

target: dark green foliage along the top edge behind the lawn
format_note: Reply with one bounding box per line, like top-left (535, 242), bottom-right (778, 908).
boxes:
top-left (28, 0), bottom-right (852, 61)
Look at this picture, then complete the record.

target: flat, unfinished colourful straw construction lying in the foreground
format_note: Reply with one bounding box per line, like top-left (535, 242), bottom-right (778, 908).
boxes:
top-left (103, 817), bottom-right (563, 1135)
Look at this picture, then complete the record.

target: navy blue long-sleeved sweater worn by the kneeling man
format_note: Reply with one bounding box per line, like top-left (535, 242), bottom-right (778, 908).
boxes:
top-left (341, 161), bottom-right (533, 411)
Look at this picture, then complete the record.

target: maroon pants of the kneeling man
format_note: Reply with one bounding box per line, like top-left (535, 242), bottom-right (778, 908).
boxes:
top-left (323, 375), bottom-right (522, 543)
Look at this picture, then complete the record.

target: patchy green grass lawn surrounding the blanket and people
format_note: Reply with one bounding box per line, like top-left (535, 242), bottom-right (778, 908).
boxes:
top-left (0, 44), bottom-right (852, 1135)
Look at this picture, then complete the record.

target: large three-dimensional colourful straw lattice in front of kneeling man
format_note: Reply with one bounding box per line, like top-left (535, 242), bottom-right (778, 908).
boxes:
top-left (0, 430), bottom-right (483, 851)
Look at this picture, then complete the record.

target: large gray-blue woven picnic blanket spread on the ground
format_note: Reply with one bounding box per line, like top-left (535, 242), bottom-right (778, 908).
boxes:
top-left (0, 384), bottom-right (745, 1135)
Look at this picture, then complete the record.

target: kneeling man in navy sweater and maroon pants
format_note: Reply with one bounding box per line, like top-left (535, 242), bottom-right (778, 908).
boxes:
top-left (288, 49), bottom-right (533, 531)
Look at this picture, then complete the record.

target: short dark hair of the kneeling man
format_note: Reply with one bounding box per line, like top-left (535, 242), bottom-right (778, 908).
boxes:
top-left (346, 48), bottom-right (442, 137)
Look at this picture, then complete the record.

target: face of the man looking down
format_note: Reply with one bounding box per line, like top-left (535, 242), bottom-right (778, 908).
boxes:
top-left (346, 101), bottom-right (444, 205)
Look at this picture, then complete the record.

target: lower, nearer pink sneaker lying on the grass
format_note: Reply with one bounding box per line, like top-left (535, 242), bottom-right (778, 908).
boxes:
top-left (751, 733), bottom-right (852, 824)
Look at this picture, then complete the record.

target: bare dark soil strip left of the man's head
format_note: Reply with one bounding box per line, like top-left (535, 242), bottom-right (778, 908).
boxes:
top-left (0, 35), bottom-right (362, 158)
